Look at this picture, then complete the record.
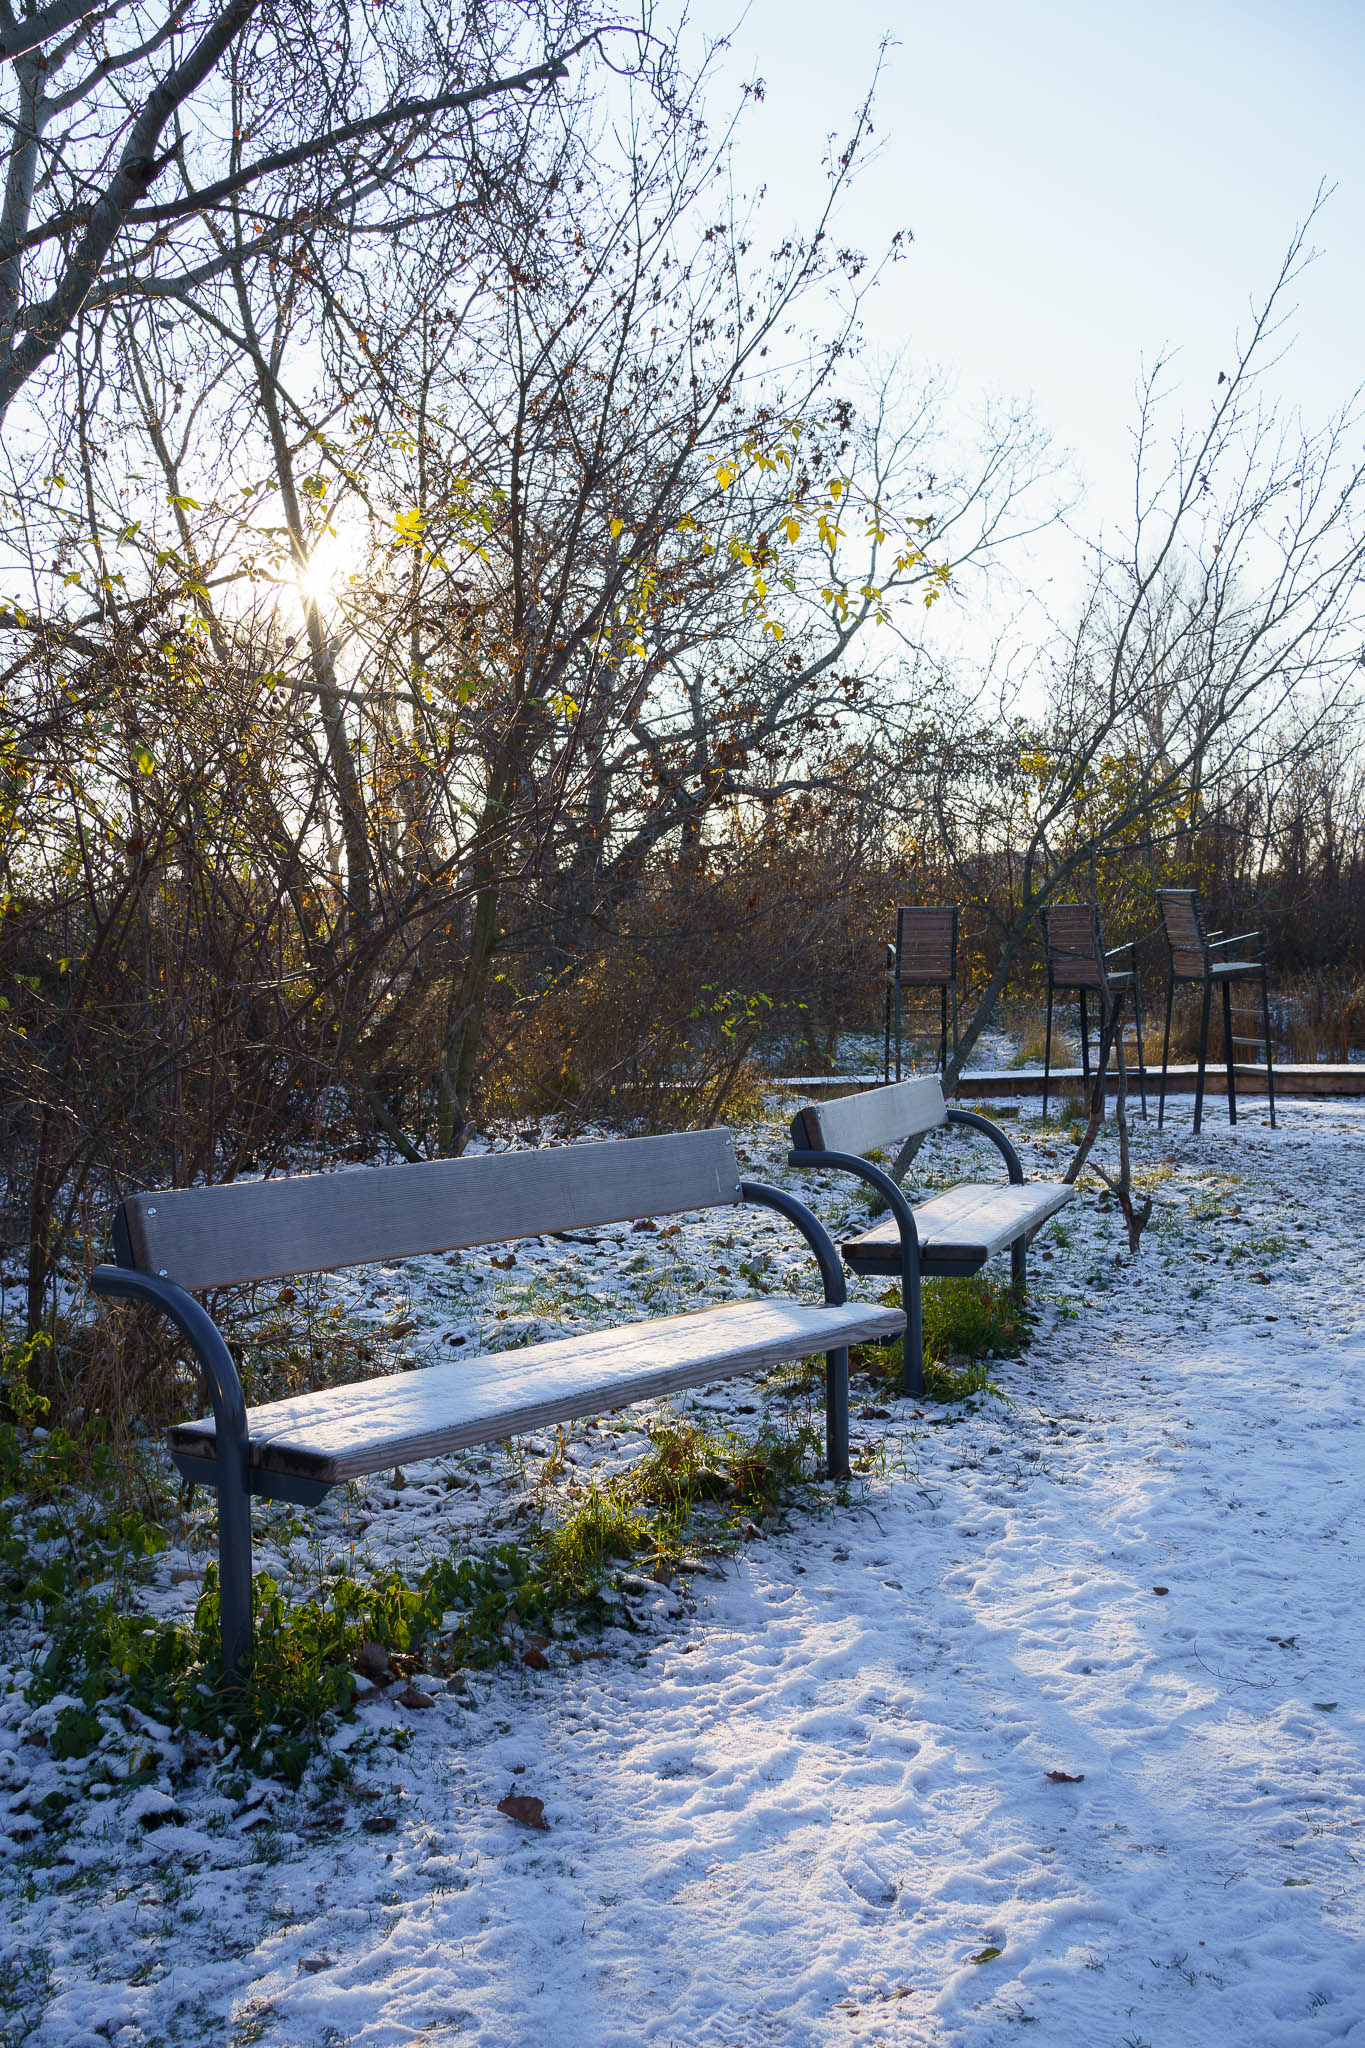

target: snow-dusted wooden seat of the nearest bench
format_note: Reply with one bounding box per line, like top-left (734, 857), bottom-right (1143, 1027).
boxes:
top-left (170, 1302), bottom-right (905, 1483)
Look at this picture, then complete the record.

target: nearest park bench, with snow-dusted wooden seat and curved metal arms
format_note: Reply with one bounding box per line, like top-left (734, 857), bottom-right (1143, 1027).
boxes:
top-left (92, 1130), bottom-right (902, 1675)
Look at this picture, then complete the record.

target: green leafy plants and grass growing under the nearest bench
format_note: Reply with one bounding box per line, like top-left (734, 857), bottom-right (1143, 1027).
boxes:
top-left (0, 1339), bottom-right (819, 1784)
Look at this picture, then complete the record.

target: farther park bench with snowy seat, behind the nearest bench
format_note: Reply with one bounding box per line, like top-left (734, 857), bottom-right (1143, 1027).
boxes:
top-left (788, 1075), bottom-right (1076, 1395)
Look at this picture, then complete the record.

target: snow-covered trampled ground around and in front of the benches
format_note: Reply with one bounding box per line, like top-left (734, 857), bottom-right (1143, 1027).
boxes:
top-left (0, 1102), bottom-right (1365, 2048)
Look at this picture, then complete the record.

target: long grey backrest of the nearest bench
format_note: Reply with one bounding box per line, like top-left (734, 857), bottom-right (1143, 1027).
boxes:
top-left (115, 1130), bottom-right (741, 1288)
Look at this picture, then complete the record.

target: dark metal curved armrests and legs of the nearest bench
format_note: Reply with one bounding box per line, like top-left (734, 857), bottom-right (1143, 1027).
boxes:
top-left (90, 1133), bottom-right (888, 1681)
